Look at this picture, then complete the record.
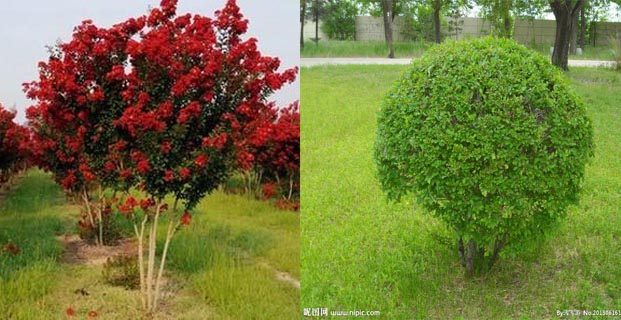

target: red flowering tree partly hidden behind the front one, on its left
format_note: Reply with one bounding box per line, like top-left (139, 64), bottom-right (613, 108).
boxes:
top-left (24, 19), bottom-right (144, 244)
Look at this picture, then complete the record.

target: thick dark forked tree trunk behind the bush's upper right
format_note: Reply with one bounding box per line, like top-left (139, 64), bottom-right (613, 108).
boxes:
top-left (550, 0), bottom-right (583, 70)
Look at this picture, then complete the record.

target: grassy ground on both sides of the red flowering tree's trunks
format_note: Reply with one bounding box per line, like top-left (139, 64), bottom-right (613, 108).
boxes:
top-left (0, 170), bottom-right (300, 319)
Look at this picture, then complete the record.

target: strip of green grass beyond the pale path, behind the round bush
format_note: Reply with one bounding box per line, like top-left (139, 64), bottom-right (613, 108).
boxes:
top-left (300, 40), bottom-right (615, 60)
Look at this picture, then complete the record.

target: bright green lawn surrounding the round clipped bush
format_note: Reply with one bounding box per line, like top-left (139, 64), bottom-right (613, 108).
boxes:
top-left (301, 66), bottom-right (621, 319)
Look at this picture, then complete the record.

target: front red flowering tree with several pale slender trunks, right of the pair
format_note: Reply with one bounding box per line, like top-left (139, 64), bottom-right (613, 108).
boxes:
top-left (115, 0), bottom-right (296, 310)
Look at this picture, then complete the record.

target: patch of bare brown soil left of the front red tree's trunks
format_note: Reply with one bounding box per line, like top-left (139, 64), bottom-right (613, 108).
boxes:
top-left (57, 235), bottom-right (138, 266)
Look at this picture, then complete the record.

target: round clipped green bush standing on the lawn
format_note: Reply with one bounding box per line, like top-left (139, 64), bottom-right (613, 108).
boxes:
top-left (374, 38), bottom-right (593, 275)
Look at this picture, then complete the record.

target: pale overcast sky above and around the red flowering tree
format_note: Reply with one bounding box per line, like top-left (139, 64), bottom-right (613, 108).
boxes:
top-left (0, 0), bottom-right (300, 122)
